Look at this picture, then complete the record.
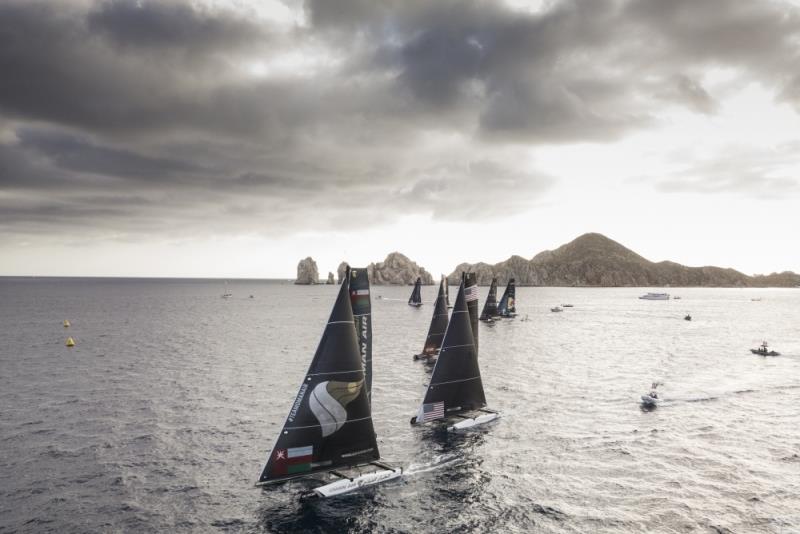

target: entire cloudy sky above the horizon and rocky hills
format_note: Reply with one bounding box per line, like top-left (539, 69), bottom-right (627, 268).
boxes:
top-left (0, 0), bottom-right (800, 278)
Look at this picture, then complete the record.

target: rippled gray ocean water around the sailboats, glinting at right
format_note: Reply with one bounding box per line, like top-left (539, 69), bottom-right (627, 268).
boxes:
top-left (0, 278), bottom-right (800, 533)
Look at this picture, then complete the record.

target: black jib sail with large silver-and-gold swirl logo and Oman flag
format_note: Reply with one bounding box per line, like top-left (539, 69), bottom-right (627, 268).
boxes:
top-left (258, 272), bottom-right (380, 484)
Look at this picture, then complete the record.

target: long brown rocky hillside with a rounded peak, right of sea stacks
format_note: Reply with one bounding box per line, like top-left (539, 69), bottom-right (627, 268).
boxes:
top-left (448, 234), bottom-right (800, 287)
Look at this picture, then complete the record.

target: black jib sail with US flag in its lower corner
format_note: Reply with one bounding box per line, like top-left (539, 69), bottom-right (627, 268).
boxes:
top-left (411, 276), bottom-right (486, 424)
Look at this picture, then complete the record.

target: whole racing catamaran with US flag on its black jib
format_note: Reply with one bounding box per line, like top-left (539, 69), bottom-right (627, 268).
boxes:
top-left (411, 273), bottom-right (500, 431)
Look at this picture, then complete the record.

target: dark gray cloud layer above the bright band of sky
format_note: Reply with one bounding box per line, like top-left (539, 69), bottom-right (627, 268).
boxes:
top-left (0, 0), bottom-right (800, 243)
